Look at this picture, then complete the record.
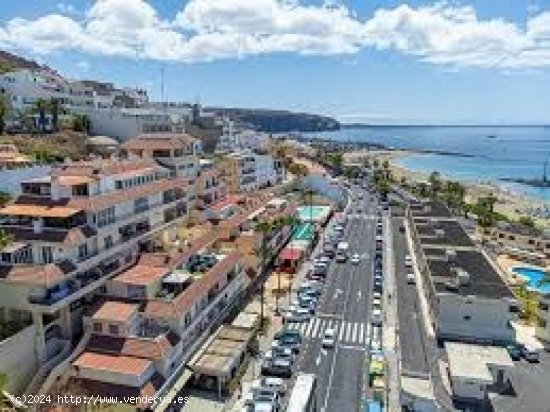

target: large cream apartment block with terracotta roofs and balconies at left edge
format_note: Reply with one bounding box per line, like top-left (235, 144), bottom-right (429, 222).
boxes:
top-left (0, 159), bottom-right (193, 392)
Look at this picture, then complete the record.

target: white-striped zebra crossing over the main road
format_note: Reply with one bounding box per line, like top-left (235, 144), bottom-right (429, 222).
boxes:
top-left (288, 317), bottom-right (370, 345)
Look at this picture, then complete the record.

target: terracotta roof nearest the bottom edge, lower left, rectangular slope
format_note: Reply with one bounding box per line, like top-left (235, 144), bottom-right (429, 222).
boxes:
top-left (73, 352), bottom-right (152, 375)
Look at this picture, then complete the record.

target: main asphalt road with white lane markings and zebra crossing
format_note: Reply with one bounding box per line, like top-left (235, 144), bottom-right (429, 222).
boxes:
top-left (288, 189), bottom-right (376, 411)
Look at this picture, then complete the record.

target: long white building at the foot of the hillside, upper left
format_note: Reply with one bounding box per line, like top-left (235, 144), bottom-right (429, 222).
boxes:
top-left (86, 108), bottom-right (174, 141)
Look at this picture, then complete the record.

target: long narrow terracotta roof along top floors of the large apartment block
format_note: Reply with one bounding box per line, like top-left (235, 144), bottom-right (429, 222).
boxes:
top-left (68, 178), bottom-right (189, 210)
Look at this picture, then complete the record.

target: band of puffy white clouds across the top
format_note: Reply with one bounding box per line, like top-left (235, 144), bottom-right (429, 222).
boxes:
top-left (0, 0), bottom-right (550, 69)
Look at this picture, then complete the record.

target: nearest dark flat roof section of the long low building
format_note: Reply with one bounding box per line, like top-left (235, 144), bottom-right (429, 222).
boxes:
top-left (428, 250), bottom-right (514, 299)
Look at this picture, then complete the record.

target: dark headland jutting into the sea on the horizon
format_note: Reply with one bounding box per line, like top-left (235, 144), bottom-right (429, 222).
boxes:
top-left (208, 108), bottom-right (340, 133)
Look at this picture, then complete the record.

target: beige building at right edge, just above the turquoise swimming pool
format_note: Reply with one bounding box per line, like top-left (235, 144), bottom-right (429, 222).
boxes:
top-left (477, 222), bottom-right (550, 266)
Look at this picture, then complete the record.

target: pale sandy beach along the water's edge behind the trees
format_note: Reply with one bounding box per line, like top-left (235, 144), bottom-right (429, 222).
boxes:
top-left (355, 150), bottom-right (550, 228)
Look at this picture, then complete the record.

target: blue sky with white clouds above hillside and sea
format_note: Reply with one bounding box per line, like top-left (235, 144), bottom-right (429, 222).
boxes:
top-left (0, 0), bottom-right (550, 124)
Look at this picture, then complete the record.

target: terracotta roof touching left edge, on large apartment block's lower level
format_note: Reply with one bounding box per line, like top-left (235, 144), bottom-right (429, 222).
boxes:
top-left (0, 261), bottom-right (76, 286)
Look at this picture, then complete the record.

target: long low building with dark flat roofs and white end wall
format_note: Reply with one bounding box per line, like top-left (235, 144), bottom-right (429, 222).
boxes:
top-left (407, 202), bottom-right (519, 342)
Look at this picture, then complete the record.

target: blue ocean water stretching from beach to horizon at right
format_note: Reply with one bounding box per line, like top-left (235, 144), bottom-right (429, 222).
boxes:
top-left (308, 126), bottom-right (550, 203)
